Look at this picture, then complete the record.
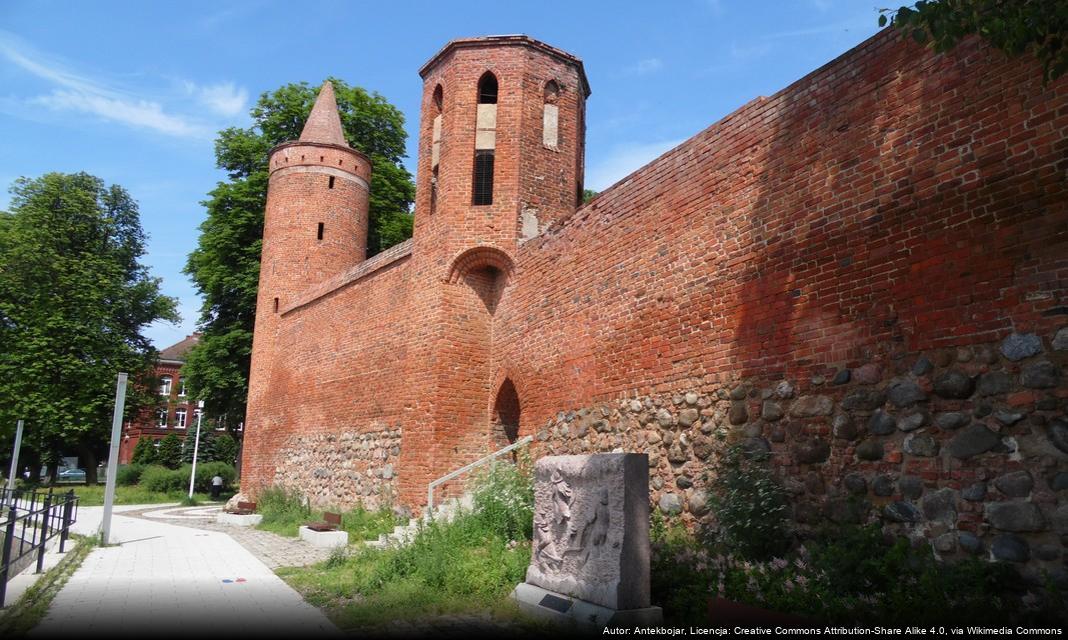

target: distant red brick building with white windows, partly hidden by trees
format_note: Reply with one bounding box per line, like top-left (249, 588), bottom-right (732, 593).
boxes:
top-left (119, 333), bottom-right (200, 465)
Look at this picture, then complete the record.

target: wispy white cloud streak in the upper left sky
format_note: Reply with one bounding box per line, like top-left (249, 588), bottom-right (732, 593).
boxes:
top-left (0, 30), bottom-right (248, 139)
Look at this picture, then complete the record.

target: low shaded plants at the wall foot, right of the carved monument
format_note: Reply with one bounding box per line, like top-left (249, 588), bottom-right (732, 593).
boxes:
top-left (651, 526), bottom-right (1068, 626)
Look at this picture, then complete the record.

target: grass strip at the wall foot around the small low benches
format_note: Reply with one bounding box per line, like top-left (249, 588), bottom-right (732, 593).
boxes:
top-left (256, 488), bottom-right (402, 542)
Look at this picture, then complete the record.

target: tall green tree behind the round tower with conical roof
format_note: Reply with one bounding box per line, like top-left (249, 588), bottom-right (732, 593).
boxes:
top-left (184, 79), bottom-right (415, 427)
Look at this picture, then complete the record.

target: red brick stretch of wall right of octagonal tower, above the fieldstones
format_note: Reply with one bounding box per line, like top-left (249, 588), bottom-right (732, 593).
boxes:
top-left (493, 34), bottom-right (1068, 432)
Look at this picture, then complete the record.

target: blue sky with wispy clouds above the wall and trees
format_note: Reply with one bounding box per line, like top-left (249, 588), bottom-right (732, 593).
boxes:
top-left (0, 0), bottom-right (878, 348)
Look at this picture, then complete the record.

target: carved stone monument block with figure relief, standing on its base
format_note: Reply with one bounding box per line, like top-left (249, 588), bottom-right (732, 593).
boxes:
top-left (513, 453), bottom-right (662, 626)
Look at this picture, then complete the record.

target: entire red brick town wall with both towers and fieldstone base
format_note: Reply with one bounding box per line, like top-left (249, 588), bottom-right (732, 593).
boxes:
top-left (242, 30), bottom-right (1068, 565)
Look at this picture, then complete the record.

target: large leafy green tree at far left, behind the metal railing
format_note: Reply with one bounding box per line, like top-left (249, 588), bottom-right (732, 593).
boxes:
top-left (0, 173), bottom-right (178, 482)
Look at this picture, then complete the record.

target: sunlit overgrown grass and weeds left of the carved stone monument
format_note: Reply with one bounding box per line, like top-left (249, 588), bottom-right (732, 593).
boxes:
top-left (279, 462), bottom-right (534, 630)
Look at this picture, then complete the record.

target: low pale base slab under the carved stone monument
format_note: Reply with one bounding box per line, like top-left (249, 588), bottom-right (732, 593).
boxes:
top-left (511, 582), bottom-right (664, 629)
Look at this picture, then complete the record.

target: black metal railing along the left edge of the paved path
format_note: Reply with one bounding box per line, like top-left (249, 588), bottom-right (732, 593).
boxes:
top-left (0, 488), bottom-right (78, 607)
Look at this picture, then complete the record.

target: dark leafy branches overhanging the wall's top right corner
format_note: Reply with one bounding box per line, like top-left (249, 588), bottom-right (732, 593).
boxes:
top-left (879, 0), bottom-right (1068, 82)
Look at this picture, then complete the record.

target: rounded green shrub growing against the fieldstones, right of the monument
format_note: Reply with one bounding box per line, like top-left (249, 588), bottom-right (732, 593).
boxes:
top-left (708, 444), bottom-right (790, 560)
